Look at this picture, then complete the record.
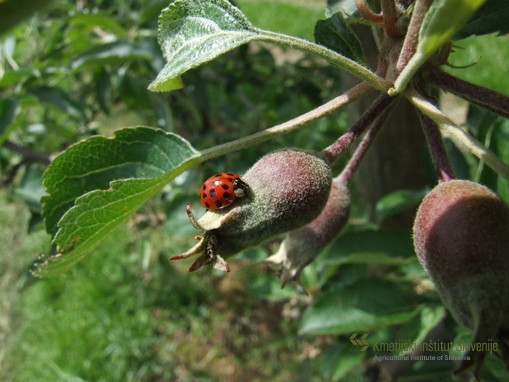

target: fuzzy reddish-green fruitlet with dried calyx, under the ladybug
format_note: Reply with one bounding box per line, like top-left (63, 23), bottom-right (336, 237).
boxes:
top-left (171, 149), bottom-right (332, 272)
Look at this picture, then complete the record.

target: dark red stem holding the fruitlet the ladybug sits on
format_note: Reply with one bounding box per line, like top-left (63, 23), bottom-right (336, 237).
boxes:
top-left (322, 93), bottom-right (395, 164)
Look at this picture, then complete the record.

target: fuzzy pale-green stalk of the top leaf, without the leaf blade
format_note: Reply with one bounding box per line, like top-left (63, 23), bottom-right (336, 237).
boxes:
top-left (256, 29), bottom-right (392, 92)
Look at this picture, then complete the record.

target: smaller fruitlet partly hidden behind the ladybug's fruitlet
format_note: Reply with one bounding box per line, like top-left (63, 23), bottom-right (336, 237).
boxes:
top-left (265, 180), bottom-right (350, 287)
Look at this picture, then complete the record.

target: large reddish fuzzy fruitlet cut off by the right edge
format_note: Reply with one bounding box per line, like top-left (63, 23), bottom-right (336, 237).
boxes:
top-left (413, 180), bottom-right (509, 378)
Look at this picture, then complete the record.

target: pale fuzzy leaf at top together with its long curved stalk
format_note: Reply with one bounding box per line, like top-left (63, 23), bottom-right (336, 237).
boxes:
top-left (149, 0), bottom-right (389, 91)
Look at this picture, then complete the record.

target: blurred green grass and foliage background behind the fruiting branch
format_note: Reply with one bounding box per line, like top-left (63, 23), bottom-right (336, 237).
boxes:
top-left (0, 0), bottom-right (509, 381)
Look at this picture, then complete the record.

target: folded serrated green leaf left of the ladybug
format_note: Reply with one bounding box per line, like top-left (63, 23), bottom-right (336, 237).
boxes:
top-left (34, 127), bottom-right (199, 276)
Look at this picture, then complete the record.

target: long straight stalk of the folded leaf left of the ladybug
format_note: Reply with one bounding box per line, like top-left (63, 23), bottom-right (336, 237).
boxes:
top-left (200, 82), bottom-right (373, 162)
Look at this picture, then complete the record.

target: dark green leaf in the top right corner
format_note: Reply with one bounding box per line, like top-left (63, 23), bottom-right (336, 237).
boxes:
top-left (455, 0), bottom-right (509, 38)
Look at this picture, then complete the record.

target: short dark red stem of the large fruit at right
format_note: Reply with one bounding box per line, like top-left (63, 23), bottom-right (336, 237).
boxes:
top-left (419, 113), bottom-right (455, 182)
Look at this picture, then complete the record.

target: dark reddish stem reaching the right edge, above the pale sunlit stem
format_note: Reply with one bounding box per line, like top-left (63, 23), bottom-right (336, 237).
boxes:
top-left (428, 69), bottom-right (509, 118)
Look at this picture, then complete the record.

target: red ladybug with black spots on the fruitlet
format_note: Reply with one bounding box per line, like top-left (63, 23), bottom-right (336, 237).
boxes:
top-left (200, 172), bottom-right (249, 210)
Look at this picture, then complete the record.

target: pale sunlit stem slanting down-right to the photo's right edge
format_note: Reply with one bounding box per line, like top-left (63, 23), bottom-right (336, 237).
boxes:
top-left (404, 89), bottom-right (509, 180)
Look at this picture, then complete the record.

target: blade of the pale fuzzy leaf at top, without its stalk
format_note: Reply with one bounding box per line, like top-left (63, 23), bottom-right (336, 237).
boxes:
top-left (149, 0), bottom-right (259, 91)
